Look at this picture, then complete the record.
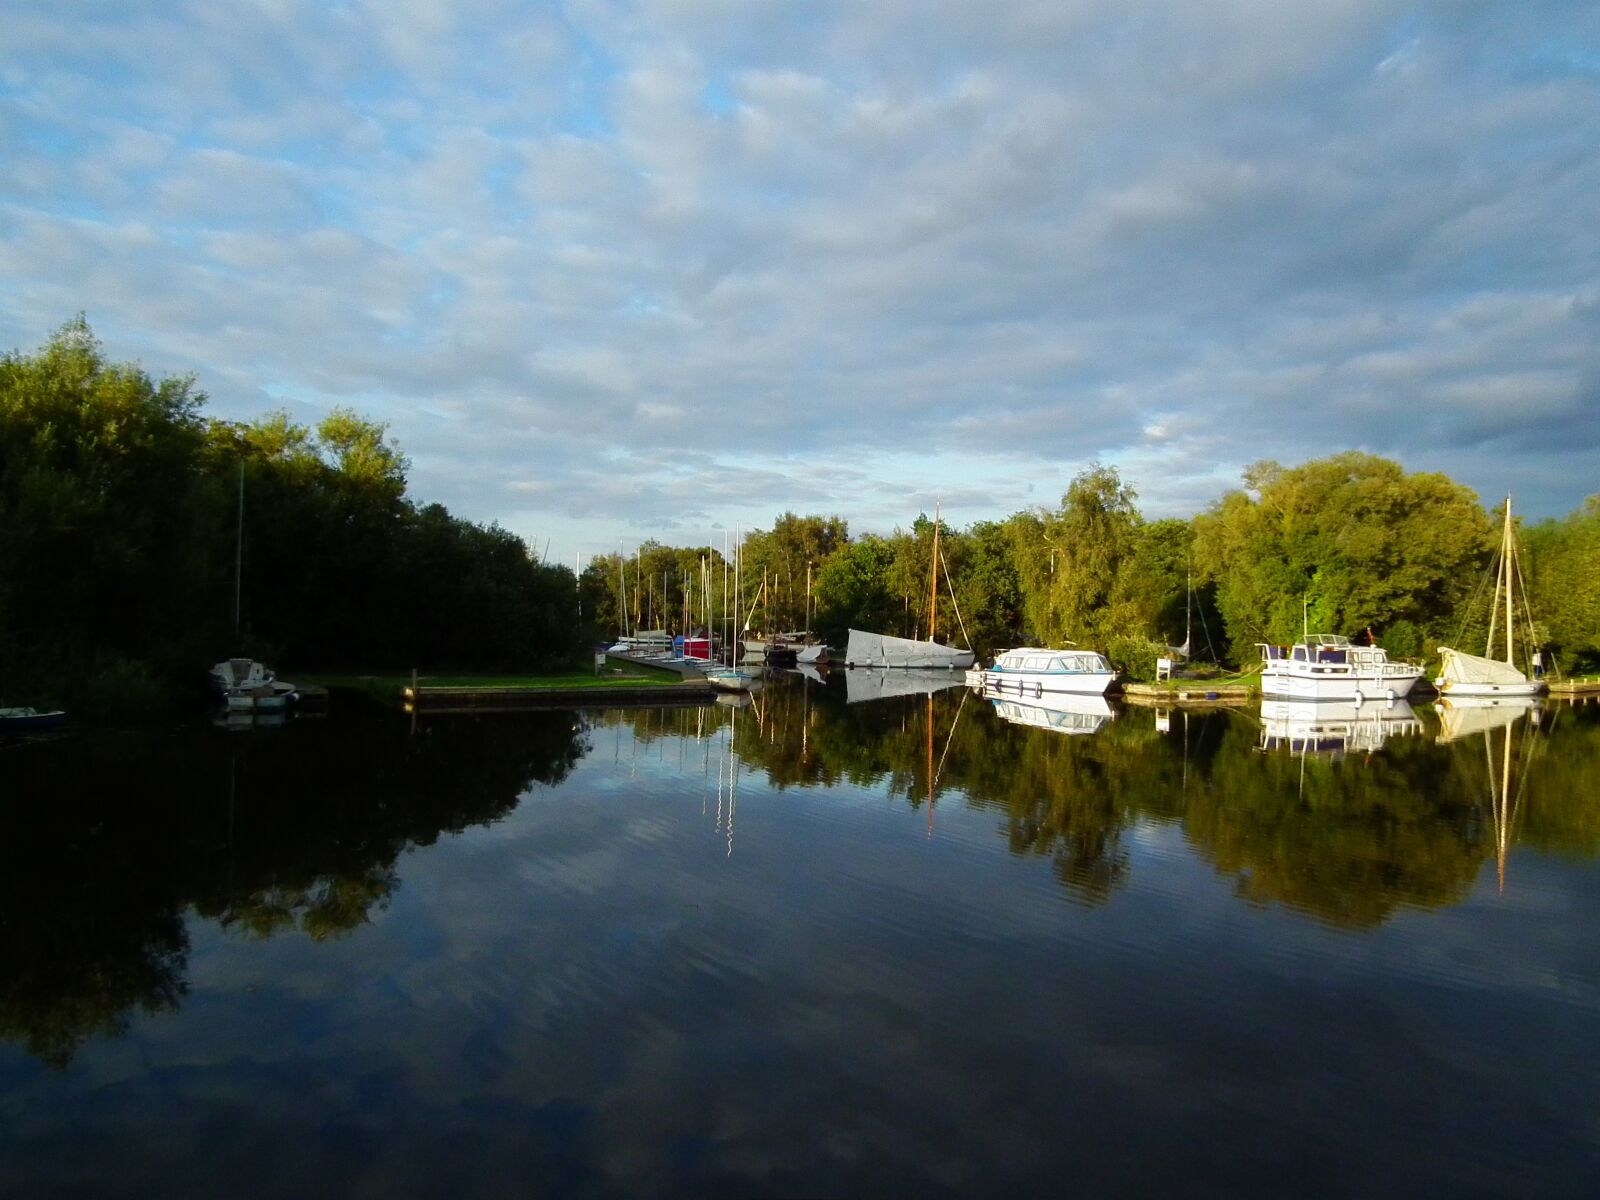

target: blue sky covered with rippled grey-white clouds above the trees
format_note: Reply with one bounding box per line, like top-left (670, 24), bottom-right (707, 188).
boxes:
top-left (0, 0), bottom-right (1600, 562)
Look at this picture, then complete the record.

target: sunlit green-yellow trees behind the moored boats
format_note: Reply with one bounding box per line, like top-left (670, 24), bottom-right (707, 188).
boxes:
top-left (581, 451), bottom-right (1600, 677)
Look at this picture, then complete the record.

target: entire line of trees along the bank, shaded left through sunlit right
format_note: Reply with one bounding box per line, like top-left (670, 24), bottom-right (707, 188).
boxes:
top-left (0, 317), bottom-right (1600, 710)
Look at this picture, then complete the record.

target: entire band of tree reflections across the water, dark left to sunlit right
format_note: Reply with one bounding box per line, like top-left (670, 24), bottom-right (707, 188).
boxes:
top-left (0, 677), bottom-right (1600, 1066)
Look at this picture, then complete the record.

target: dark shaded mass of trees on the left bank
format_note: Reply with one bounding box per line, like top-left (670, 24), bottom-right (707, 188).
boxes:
top-left (0, 317), bottom-right (576, 710)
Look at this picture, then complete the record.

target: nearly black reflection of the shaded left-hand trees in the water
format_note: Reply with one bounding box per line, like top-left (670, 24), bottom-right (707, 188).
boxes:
top-left (0, 712), bottom-right (586, 1067)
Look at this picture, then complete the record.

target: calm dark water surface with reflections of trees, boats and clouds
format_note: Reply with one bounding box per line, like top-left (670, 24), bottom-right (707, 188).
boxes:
top-left (0, 677), bottom-right (1600, 1197)
